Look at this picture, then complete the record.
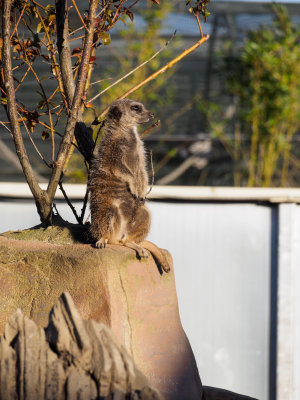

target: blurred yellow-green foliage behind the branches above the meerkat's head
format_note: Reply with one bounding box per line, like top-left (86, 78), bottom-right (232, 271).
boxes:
top-left (95, 0), bottom-right (178, 108)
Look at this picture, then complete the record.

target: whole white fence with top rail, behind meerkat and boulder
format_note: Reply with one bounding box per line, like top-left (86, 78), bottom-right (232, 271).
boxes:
top-left (0, 186), bottom-right (300, 400)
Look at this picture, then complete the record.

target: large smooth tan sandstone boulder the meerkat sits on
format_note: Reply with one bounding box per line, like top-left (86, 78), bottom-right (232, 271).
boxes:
top-left (0, 233), bottom-right (202, 400)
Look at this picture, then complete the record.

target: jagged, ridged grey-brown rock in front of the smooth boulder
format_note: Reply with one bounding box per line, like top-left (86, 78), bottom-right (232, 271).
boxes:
top-left (0, 293), bottom-right (162, 400)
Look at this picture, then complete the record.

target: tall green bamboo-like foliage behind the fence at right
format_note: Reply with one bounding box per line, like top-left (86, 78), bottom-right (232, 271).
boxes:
top-left (206, 6), bottom-right (300, 186)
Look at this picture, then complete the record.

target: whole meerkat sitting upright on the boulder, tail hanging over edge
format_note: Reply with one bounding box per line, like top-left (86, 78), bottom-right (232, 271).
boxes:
top-left (88, 99), bottom-right (170, 272)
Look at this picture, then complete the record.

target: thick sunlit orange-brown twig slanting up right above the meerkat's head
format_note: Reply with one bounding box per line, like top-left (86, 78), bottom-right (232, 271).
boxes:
top-left (98, 35), bottom-right (209, 119)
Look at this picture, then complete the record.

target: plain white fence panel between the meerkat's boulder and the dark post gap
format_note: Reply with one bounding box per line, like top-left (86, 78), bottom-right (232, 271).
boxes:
top-left (150, 203), bottom-right (272, 400)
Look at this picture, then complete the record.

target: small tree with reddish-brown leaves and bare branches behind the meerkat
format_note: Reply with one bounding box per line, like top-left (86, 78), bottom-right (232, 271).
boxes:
top-left (0, 0), bottom-right (208, 224)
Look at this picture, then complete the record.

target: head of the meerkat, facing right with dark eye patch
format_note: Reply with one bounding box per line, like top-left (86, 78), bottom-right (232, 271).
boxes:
top-left (107, 99), bottom-right (154, 128)
